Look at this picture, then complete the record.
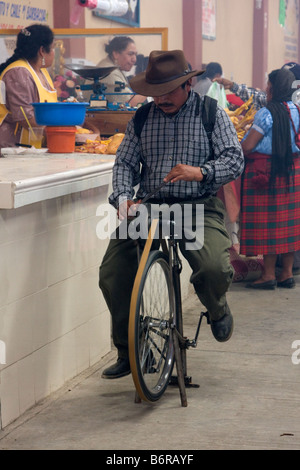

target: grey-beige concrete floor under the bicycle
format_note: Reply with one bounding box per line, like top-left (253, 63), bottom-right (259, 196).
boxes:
top-left (0, 276), bottom-right (300, 451)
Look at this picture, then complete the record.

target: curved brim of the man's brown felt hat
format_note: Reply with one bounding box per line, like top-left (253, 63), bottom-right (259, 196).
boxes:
top-left (129, 70), bottom-right (204, 97)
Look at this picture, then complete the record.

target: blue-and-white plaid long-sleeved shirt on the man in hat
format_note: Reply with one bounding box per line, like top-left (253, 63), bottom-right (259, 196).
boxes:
top-left (109, 90), bottom-right (244, 207)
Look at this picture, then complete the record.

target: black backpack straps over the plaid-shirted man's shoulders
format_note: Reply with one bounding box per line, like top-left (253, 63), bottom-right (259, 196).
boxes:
top-left (133, 94), bottom-right (218, 158)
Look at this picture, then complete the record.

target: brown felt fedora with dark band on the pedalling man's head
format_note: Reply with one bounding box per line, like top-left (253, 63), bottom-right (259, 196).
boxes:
top-left (129, 50), bottom-right (204, 96)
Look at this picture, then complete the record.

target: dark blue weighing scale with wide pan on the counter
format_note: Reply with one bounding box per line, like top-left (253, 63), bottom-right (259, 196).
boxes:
top-left (65, 64), bottom-right (136, 111)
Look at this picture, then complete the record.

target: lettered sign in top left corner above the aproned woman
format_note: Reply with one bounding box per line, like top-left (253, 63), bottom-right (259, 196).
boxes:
top-left (0, 0), bottom-right (52, 29)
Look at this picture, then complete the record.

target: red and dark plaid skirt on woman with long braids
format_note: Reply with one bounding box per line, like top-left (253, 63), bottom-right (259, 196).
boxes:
top-left (240, 153), bottom-right (300, 256)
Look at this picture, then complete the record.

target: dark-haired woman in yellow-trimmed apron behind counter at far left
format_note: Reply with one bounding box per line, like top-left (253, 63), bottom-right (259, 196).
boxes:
top-left (0, 24), bottom-right (57, 148)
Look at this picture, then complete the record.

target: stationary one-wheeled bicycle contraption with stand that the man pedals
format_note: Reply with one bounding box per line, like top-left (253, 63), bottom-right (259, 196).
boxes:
top-left (128, 219), bottom-right (203, 407)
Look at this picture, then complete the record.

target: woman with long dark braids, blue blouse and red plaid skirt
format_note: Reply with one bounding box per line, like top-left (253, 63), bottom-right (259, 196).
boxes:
top-left (240, 69), bottom-right (300, 290)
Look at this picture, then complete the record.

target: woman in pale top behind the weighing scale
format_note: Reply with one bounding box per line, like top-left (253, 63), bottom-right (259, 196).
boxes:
top-left (97, 36), bottom-right (146, 107)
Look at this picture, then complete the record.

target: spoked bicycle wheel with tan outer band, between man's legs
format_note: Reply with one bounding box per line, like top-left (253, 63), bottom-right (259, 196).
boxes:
top-left (129, 251), bottom-right (176, 401)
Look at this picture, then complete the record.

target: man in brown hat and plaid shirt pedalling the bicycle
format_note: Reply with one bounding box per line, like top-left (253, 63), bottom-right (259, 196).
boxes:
top-left (99, 50), bottom-right (244, 379)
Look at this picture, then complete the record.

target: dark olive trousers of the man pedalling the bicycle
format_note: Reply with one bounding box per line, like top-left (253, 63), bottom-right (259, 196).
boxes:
top-left (99, 197), bottom-right (234, 358)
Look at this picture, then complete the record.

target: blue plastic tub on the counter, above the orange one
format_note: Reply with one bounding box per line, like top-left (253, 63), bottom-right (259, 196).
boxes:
top-left (32, 102), bottom-right (89, 126)
